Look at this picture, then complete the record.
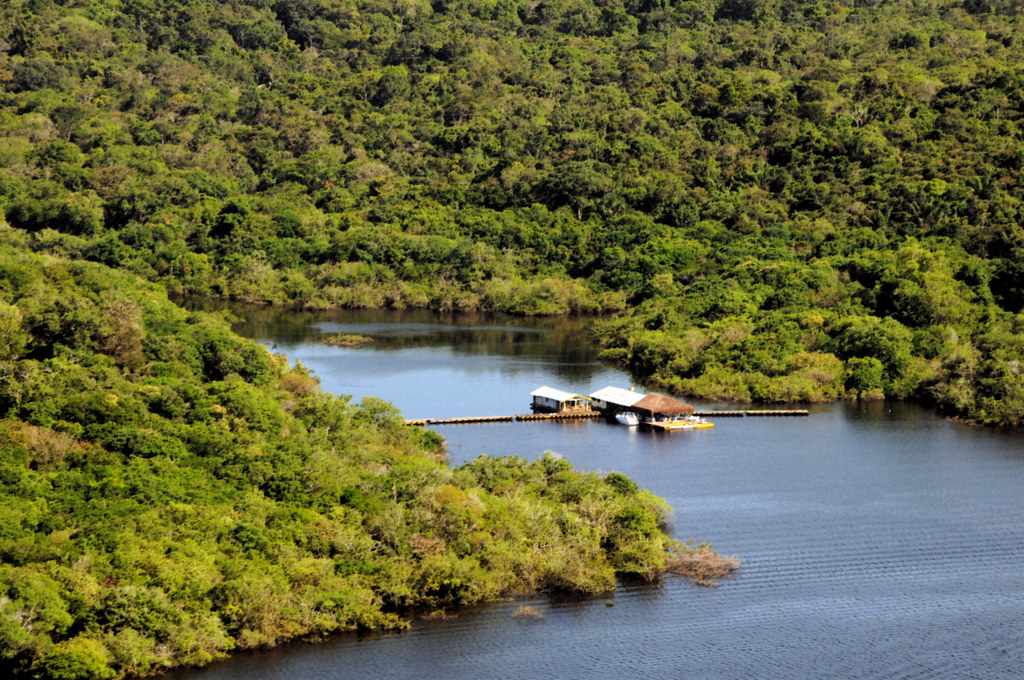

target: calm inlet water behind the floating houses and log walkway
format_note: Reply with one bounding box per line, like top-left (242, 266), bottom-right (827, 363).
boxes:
top-left (200, 306), bottom-right (629, 418)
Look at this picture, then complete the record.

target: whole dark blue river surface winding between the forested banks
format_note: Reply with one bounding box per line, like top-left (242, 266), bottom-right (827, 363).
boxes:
top-left (170, 311), bottom-right (1024, 680)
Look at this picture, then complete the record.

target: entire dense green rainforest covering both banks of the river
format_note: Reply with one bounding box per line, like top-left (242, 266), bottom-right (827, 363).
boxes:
top-left (0, 0), bottom-right (1024, 678)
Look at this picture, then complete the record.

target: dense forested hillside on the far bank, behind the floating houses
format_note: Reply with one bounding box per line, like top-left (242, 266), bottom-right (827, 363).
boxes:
top-left (0, 0), bottom-right (1024, 425)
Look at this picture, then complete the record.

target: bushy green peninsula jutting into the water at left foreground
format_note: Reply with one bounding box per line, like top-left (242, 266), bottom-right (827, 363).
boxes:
top-left (0, 244), bottom-right (737, 680)
